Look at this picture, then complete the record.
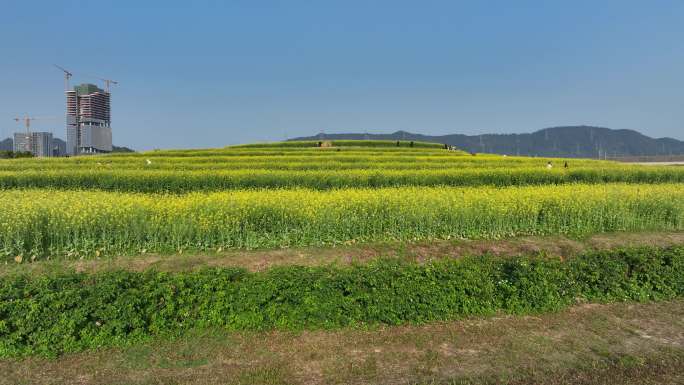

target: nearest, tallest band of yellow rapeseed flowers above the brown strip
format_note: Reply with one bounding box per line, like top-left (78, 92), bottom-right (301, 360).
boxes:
top-left (0, 184), bottom-right (684, 260)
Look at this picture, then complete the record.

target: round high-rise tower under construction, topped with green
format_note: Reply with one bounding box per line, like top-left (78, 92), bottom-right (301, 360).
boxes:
top-left (66, 84), bottom-right (112, 155)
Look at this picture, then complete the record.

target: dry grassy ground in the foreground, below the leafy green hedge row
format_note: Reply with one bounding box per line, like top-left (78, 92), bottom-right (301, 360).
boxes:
top-left (0, 300), bottom-right (684, 384)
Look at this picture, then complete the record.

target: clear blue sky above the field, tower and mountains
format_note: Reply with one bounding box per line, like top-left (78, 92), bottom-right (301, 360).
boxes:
top-left (0, 0), bottom-right (684, 149)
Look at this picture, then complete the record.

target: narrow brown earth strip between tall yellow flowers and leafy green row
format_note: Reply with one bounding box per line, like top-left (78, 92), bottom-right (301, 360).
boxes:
top-left (0, 232), bottom-right (684, 275)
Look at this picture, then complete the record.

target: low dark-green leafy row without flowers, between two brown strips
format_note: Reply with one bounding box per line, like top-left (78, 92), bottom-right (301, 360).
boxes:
top-left (0, 247), bottom-right (684, 357)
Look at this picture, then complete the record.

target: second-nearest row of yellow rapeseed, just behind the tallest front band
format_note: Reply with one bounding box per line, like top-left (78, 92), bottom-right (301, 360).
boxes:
top-left (0, 166), bottom-right (684, 193)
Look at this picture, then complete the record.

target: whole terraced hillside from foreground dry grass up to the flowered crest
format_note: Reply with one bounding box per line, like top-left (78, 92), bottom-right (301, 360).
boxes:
top-left (0, 141), bottom-right (684, 384)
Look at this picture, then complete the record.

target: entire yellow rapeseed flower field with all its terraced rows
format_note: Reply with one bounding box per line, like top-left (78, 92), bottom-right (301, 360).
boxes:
top-left (0, 141), bottom-right (684, 261)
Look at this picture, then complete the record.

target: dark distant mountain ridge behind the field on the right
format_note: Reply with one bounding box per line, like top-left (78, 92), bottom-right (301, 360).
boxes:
top-left (289, 126), bottom-right (684, 158)
